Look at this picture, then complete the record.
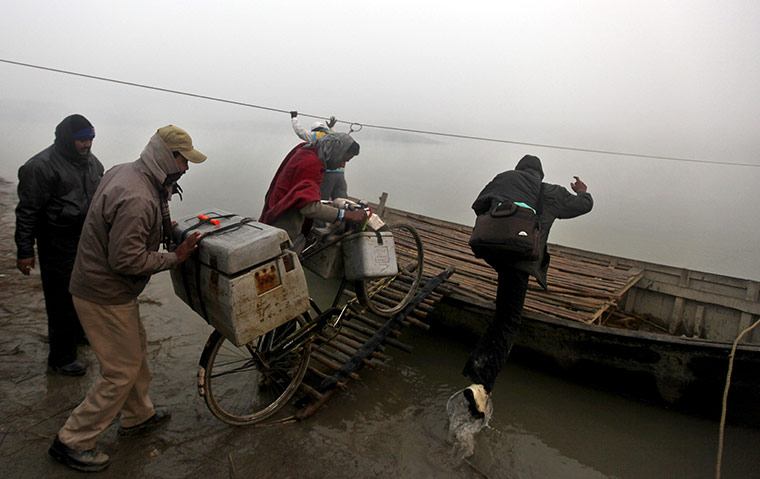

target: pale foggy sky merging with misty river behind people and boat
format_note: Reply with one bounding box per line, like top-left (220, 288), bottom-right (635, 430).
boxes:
top-left (0, 1), bottom-right (760, 279)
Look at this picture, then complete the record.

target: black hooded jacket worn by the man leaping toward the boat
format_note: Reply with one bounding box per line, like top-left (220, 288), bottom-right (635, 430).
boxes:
top-left (472, 155), bottom-right (594, 289)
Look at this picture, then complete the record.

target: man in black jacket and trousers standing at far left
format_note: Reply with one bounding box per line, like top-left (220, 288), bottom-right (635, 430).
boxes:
top-left (15, 115), bottom-right (103, 376)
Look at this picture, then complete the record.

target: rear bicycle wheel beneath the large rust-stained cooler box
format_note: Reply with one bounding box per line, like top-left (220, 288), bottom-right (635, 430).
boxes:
top-left (198, 315), bottom-right (310, 426)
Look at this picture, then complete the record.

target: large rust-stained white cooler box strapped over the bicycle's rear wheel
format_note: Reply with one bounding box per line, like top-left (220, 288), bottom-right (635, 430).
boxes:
top-left (171, 209), bottom-right (309, 346)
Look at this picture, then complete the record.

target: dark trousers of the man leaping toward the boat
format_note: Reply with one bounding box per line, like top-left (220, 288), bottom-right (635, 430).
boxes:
top-left (462, 266), bottom-right (528, 393)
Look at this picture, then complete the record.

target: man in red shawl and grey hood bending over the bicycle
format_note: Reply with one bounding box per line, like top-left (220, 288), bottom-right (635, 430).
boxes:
top-left (259, 133), bottom-right (366, 250)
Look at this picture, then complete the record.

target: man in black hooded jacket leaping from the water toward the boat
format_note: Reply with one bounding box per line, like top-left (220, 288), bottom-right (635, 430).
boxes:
top-left (462, 155), bottom-right (594, 418)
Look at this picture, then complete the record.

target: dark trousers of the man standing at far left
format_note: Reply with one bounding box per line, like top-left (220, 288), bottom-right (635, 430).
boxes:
top-left (38, 241), bottom-right (84, 366)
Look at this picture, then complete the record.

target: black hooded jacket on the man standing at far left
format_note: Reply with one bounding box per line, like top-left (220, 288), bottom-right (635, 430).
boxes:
top-left (15, 115), bottom-right (103, 261)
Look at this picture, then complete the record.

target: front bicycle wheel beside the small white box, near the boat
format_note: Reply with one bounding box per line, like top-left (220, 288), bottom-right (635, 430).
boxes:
top-left (355, 224), bottom-right (424, 317)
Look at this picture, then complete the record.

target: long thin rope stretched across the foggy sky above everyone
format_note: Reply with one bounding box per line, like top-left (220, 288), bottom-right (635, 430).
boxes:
top-left (0, 58), bottom-right (760, 168)
